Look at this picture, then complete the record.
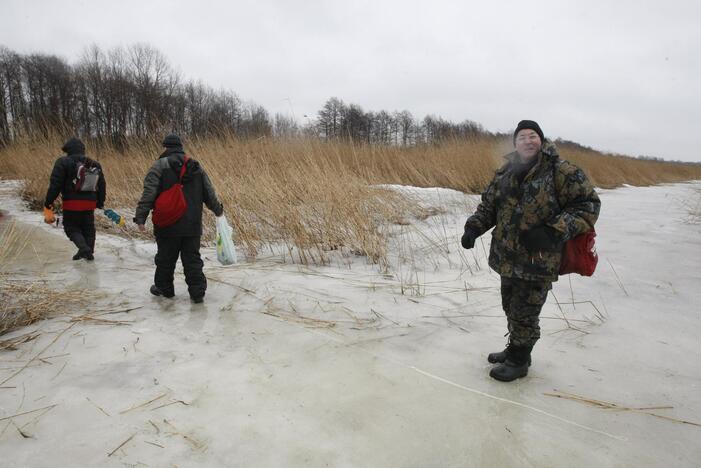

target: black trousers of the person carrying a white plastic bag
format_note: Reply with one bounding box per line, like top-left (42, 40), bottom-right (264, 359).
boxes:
top-left (153, 236), bottom-right (207, 298)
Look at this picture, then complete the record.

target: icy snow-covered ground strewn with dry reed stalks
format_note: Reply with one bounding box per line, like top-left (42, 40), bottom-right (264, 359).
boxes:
top-left (0, 181), bottom-right (701, 467)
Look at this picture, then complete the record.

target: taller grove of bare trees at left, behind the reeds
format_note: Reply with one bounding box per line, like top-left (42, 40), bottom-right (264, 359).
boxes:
top-left (0, 44), bottom-right (271, 144)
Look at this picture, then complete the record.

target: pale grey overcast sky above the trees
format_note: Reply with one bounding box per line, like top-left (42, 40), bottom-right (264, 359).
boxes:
top-left (0, 0), bottom-right (701, 161)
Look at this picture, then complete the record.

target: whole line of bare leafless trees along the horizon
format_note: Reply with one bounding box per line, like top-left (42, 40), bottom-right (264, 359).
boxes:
top-left (0, 44), bottom-right (488, 147)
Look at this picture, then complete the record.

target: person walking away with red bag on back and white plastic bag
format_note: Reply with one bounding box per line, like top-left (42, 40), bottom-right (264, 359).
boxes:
top-left (134, 134), bottom-right (224, 303)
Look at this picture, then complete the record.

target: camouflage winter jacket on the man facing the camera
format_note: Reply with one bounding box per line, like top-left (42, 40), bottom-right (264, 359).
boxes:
top-left (465, 140), bottom-right (601, 281)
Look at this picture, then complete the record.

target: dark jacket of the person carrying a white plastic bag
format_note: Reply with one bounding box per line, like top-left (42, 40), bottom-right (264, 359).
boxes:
top-left (134, 148), bottom-right (224, 237)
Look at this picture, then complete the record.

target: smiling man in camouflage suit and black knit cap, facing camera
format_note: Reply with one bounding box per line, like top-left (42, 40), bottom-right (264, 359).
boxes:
top-left (462, 120), bottom-right (601, 381)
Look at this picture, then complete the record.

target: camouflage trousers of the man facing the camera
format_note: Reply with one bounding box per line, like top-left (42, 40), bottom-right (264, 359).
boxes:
top-left (501, 276), bottom-right (552, 348)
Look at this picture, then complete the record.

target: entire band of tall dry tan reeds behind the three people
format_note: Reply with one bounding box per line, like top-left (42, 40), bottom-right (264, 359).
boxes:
top-left (0, 134), bottom-right (701, 263)
